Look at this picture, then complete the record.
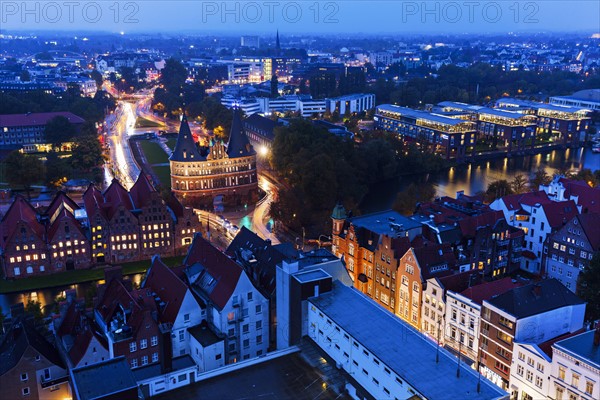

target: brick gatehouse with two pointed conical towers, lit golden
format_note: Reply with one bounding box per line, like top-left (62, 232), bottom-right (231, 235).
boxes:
top-left (169, 110), bottom-right (258, 206)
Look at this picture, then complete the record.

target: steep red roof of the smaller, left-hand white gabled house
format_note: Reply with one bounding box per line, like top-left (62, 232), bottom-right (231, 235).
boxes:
top-left (142, 256), bottom-right (188, 323)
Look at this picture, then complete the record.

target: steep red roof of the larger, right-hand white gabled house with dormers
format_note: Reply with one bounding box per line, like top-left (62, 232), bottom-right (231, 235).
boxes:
top-left (184, 234), bottom-right (242, 309)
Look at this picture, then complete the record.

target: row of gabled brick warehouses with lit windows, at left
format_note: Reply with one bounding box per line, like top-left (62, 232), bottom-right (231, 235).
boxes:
top-left (0, 174), bottom-right (200, 279)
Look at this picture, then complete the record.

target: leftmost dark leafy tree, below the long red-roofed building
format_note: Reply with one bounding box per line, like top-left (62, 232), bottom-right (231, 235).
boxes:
top-left (4, 151), bottom-right (45, 200)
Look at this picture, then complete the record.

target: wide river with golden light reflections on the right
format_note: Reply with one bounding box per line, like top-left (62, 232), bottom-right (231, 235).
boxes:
top-left (361, 148), bottom-right (600, 213)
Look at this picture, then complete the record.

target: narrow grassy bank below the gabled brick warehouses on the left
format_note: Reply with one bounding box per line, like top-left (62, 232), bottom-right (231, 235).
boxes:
top-left (0, 256), bottom-right (184, 294)
